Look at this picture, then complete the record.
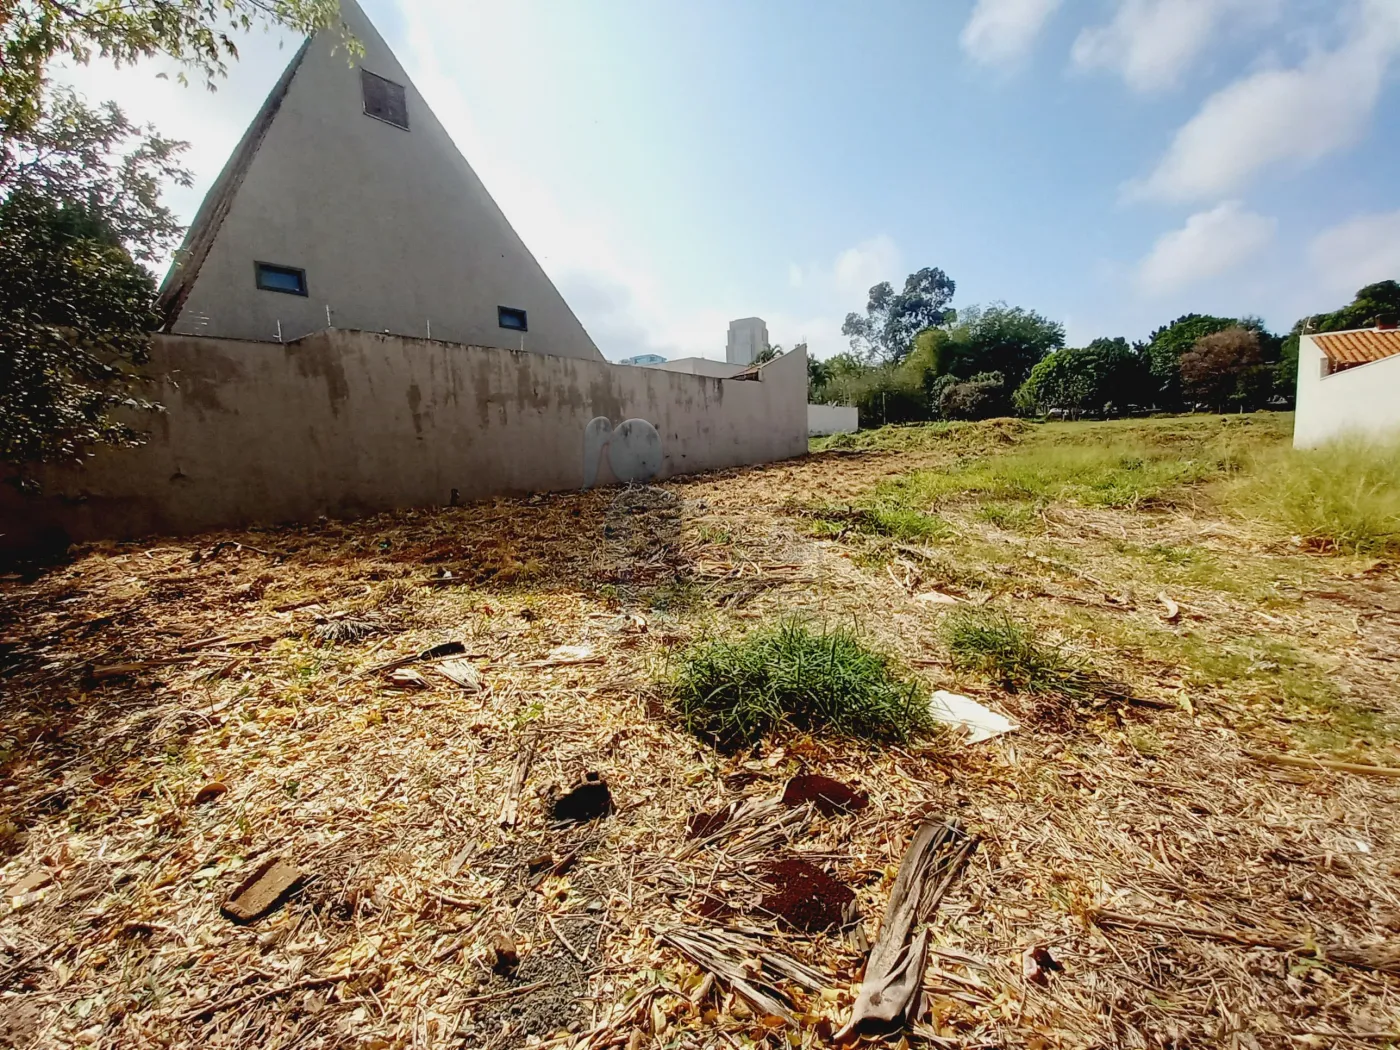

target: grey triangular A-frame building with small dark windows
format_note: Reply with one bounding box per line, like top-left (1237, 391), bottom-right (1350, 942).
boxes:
top-left (160, 0), bottom-right (602, 361)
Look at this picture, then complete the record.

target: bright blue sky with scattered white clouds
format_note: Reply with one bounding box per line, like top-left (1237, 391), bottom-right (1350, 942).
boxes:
top-left (54, 0), bottom-right (1400, 358)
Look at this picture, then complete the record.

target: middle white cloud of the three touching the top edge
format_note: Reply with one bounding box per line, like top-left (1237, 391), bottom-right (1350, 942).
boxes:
top-left (1071, 0), bottom-right (1278, 91)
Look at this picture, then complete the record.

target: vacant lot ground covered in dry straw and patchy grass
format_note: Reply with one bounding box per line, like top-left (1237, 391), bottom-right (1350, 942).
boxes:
top-left (0, 414), bottom-right (1400, 1049)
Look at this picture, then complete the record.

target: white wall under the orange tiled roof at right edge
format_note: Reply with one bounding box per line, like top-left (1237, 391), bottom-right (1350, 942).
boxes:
top-left (1294, 336), bottom-right (1400, 448)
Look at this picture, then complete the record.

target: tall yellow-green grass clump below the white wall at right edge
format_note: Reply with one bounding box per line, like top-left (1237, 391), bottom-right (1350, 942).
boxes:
top-left (1222, 438), bottom-right (1400, 554)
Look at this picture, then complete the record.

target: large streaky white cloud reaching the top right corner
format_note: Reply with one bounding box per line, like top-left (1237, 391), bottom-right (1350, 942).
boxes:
top-left (1128, 0), bottom-right (1400, 200)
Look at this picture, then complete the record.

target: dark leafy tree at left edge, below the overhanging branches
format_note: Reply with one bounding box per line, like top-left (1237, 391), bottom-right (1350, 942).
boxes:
top-left (0, 91), bottom-right (189, 476)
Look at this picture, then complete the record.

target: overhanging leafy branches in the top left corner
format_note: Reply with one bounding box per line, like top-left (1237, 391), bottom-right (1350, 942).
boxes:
top-left (0, 0), bottom-right (344, 139)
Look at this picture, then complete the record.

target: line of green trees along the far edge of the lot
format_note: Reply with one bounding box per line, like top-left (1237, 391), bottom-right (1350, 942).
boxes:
top-left (808, 267), bottom-right (1400, 426)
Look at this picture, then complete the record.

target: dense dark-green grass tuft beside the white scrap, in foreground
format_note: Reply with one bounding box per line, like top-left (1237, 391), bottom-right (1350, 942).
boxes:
top-left (672, 620), bottom-right (934, 748)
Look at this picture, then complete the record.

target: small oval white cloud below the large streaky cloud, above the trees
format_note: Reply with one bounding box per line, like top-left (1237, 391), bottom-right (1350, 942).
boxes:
top-left (1137, 200), bottom-right (1277, 295)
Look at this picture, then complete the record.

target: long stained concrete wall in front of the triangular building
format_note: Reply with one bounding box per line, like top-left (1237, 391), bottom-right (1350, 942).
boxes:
top-left (0, 330), bottom-right (806, 546)
